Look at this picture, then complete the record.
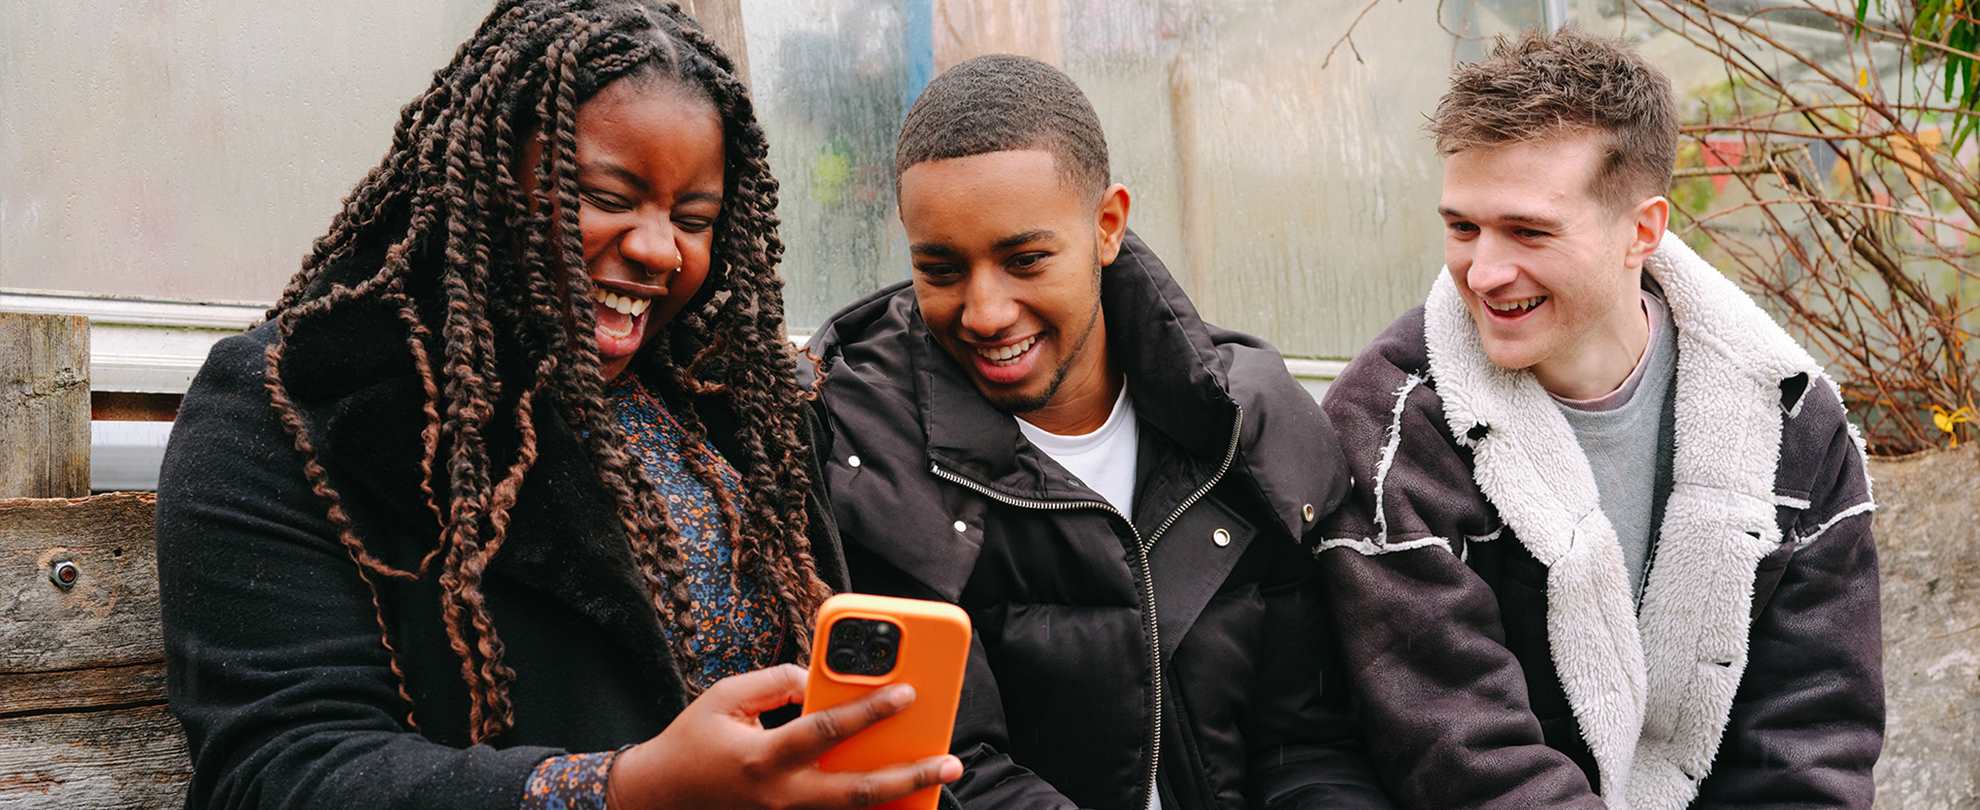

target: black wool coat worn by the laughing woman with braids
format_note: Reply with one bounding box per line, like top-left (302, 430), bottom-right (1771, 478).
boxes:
top-left (158, 295), bottom-right (845, 810)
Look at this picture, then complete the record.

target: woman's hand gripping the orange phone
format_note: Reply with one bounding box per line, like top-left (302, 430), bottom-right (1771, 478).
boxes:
top-left (606, 663), bottom-right (962, 810)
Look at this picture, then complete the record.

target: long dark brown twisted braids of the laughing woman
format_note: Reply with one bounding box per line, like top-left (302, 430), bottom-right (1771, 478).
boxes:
top-left (267, 0), bottom-right (830, 743)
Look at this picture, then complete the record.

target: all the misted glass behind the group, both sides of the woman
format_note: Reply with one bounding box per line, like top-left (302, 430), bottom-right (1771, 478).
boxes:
top-left (0, 0), bottom-right (1542, 356)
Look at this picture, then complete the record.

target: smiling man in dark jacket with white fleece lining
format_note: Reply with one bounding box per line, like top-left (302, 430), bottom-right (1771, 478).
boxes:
top-left (1317, 32), bottom-right (1883, 810)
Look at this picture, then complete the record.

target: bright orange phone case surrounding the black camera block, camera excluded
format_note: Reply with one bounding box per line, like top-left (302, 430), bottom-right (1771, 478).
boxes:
top-left (804, 594), bottom-right (970, 810)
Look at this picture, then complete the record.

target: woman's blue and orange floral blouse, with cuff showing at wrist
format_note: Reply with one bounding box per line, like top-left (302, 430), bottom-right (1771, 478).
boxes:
top-left (523, 374), bottom-right (784, 810)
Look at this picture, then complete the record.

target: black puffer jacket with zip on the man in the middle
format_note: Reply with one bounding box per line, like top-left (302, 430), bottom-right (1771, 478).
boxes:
top-left (816, 236), bottom-right (1386, 810)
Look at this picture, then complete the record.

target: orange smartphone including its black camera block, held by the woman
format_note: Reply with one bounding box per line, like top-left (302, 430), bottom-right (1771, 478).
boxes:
top-left (798, 594), bottom-right (970, 810)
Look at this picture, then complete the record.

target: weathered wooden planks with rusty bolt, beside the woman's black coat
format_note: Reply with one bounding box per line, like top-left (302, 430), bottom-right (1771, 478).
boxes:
top-left (0, 493), bottom-right (192, 808)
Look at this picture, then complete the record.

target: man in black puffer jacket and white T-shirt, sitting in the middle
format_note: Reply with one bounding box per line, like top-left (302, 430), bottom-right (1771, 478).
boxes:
top-left (814, 55), bottom-right (1388, 810)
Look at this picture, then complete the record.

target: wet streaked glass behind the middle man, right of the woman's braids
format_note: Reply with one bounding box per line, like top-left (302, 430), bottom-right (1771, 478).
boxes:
top-left (744, 0), bottom-right (1540, 356)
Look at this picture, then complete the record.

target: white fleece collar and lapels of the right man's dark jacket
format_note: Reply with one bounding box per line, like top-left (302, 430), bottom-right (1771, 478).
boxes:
top-left (1424, 234), bottom-right (1822, 808)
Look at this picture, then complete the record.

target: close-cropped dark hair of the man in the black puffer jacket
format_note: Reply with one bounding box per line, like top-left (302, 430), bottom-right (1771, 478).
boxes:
top-left (893, 53), bottom-right (1109, 196)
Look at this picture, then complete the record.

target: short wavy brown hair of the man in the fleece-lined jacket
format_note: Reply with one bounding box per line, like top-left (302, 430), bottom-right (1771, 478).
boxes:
top-left (1428, 28), bottom-right (1677, 210)
